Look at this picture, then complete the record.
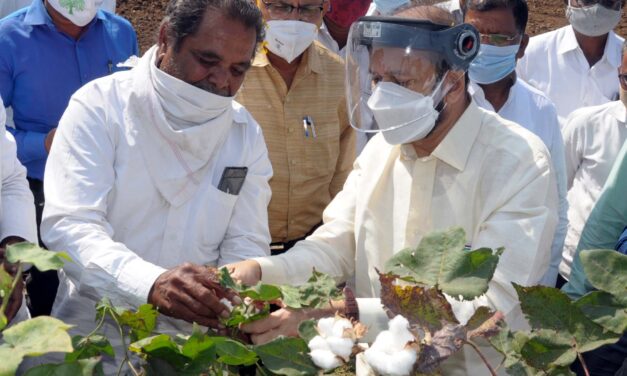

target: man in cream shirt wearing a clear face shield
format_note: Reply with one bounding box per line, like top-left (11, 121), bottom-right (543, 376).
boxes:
top-left (230, 2), bottom-right (557, 375)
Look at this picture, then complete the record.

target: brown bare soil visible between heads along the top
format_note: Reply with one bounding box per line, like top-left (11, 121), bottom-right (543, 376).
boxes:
top-left (117, 0), bottom-right (627, 52)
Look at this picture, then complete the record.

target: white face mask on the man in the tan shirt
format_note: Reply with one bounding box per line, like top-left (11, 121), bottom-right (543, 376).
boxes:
top-left (266, 20), bottom-right (318, 63)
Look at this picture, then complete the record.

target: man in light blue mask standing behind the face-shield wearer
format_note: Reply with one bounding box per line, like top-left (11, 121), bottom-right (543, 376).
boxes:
top-left (465, 0), bottom-right (568, 287)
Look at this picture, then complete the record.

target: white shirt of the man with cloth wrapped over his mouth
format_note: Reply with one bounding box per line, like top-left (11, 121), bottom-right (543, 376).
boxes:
top-left (41, 49), bottom-right (272, 368)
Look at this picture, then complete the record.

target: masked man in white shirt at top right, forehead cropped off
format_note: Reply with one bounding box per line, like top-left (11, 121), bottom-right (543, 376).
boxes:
top-left (517, 0), bottom-right (623, 127)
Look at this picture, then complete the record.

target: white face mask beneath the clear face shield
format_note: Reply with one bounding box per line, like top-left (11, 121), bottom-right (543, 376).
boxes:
top-left (368, 82), bottom-right (439, 145)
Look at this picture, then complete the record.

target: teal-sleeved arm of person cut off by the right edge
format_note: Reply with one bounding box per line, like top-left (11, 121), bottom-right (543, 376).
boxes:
top-left (562, 143), bottom-right (627, 299)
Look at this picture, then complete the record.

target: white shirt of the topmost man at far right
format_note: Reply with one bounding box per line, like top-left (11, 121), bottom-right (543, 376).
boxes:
top-left (517, 25), bottom-right (623, 126)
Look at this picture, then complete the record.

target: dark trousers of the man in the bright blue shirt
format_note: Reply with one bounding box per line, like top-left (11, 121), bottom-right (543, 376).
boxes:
top-left (26, 178), bottom-right (59, 317)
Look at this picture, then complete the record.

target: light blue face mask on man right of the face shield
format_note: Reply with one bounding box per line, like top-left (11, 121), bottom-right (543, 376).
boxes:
top-left (468, 44), bottom-right (520, 85)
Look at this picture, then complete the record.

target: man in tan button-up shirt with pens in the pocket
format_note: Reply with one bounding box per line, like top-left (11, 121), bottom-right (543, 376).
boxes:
top-left (237, 0), bottom-right (356, 253)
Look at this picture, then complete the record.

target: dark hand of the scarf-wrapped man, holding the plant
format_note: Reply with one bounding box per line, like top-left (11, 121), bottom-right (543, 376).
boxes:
top-left (148, 263), bottom-right (237, 329)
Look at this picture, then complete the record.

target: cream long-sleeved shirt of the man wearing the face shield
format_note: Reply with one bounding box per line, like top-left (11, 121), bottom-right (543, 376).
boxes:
top-left (256, 103), bottom-right (557, 375)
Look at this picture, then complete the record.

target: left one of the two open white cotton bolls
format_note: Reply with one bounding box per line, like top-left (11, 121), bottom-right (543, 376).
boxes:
top-left (308, 316), bottom-right (366, 371)
